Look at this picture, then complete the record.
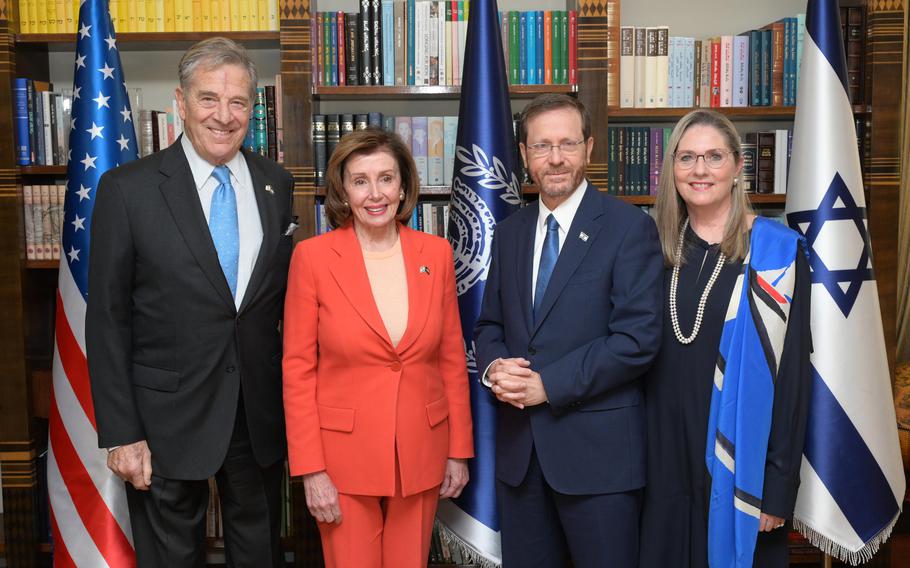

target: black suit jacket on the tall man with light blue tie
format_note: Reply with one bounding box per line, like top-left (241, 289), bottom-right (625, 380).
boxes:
top-left (86, 140), bottom-right (294, 479)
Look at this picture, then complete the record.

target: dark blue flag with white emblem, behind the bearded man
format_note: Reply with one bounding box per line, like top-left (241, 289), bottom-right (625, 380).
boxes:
top-left (437, 0), bottom-right (521, 566)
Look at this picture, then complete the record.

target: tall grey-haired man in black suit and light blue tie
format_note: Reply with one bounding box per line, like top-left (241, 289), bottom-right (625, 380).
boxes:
top-left (86, 38), bottom-right (295, 567)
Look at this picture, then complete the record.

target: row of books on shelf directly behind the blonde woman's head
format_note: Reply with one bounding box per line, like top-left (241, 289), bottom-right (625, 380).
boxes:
top-left (606, 126), bottom-right (793, 195)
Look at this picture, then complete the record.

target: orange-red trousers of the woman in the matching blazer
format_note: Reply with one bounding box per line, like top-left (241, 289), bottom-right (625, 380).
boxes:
top-left (317, 460), bottom-right (439, 568)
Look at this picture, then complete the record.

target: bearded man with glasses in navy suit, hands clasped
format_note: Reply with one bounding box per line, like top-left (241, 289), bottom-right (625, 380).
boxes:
top-left (475, 95), bottom-right (663, 568)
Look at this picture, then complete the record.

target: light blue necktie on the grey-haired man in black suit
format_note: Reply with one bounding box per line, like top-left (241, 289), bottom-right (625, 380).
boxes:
top-left (209, 166), bottom-right (240, 296)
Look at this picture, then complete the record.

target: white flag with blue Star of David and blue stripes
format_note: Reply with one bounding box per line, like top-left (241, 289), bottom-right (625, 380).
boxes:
top-left (786, 0), bottom-right (906, 565)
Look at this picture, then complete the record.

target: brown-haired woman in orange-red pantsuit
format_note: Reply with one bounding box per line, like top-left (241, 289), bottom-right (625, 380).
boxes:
top-left (283, 129), bottom-right (473, 568)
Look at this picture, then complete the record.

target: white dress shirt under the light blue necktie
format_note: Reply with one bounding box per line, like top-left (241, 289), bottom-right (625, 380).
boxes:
top-left (180, 135), bottom-right (262, 309)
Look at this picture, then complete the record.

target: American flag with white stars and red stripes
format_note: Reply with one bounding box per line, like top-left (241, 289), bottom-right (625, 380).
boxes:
top-left (47, 0), bottom-right (138, 568)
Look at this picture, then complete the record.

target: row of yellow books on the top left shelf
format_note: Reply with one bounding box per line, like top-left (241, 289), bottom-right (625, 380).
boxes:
top-left (19, 0), bottom-right (279, 34)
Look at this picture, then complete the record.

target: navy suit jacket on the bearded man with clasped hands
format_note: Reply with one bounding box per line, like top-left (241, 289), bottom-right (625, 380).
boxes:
top-left (474, 184), bottom-right (663, 495)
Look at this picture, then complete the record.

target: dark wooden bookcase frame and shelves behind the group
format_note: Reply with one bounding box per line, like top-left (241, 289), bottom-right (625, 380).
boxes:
top-left (0, 0), bottom-right (906, 567)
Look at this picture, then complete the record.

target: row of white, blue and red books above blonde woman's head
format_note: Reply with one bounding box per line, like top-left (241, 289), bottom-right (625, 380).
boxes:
top-left (620, 14), bottom-right (806, 108)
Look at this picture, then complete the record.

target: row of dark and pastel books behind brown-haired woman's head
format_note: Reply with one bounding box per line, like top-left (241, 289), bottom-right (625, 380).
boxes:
top-left (313, 112), bottom-right (458, 186)
